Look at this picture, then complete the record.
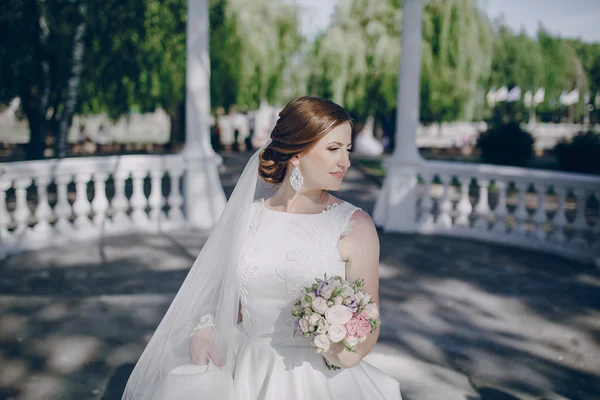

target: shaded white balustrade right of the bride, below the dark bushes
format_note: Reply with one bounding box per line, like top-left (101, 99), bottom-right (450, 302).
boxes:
top-left (417, 161), bottom-right (600, 262)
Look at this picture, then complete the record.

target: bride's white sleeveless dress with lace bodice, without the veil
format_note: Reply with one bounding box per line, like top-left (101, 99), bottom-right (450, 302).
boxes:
top-left (234, 199), bottom-right (401, 400)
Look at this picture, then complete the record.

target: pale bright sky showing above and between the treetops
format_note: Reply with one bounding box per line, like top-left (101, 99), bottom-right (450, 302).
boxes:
top-left (290, 0), bottom-right (600, 42)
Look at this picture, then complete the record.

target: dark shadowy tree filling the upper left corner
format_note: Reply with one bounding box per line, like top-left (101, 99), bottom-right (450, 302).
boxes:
top-left (0, 0), bottom-right (86, 159)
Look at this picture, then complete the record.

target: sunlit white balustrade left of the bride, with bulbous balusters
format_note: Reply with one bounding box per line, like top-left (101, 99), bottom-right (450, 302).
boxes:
top-left (0, 155), bottom-right (187, 259)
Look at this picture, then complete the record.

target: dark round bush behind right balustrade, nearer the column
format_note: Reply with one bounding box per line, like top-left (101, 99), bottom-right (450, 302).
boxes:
top-left (477, 122), bottom-right (534, 167)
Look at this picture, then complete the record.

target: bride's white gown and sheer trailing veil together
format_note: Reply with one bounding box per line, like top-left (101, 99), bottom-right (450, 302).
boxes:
top-left (123, 137), bottom-right (400, 400)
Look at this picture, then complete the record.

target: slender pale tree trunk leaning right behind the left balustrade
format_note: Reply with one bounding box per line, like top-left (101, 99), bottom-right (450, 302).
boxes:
top-left (56, 2), bottom-right (86, 158)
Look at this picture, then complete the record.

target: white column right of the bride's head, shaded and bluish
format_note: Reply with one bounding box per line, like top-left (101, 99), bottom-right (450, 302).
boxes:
top-left (373, 0), bottom-right (423, 233)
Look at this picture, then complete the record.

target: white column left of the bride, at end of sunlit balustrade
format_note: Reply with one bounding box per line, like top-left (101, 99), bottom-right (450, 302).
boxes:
top-left (183, 0), bottom-right (226, 229)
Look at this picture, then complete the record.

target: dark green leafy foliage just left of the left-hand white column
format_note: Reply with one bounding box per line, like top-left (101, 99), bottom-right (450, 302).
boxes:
top-left (79, 0), bottom-right (187, 118)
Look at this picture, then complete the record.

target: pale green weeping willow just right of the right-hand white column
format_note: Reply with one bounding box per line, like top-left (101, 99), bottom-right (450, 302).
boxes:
top-left (421, 0), bottom-right (494, 121)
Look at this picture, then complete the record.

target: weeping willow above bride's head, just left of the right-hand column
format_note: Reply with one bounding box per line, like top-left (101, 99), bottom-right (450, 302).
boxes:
top-left (311, 0), bottom-right (401, 119)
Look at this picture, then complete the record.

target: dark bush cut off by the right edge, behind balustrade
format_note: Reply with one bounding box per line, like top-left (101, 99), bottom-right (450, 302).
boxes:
top-left (554, 131), bottom-right (600, 175)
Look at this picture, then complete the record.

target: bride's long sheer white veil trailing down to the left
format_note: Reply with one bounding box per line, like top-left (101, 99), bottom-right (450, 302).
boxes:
top-left (123, 140), bottom-right (276, 400)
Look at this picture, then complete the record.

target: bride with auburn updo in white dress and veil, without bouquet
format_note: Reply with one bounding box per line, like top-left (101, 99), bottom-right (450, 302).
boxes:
top-left (123, 97), bottom-right (401, 400)
